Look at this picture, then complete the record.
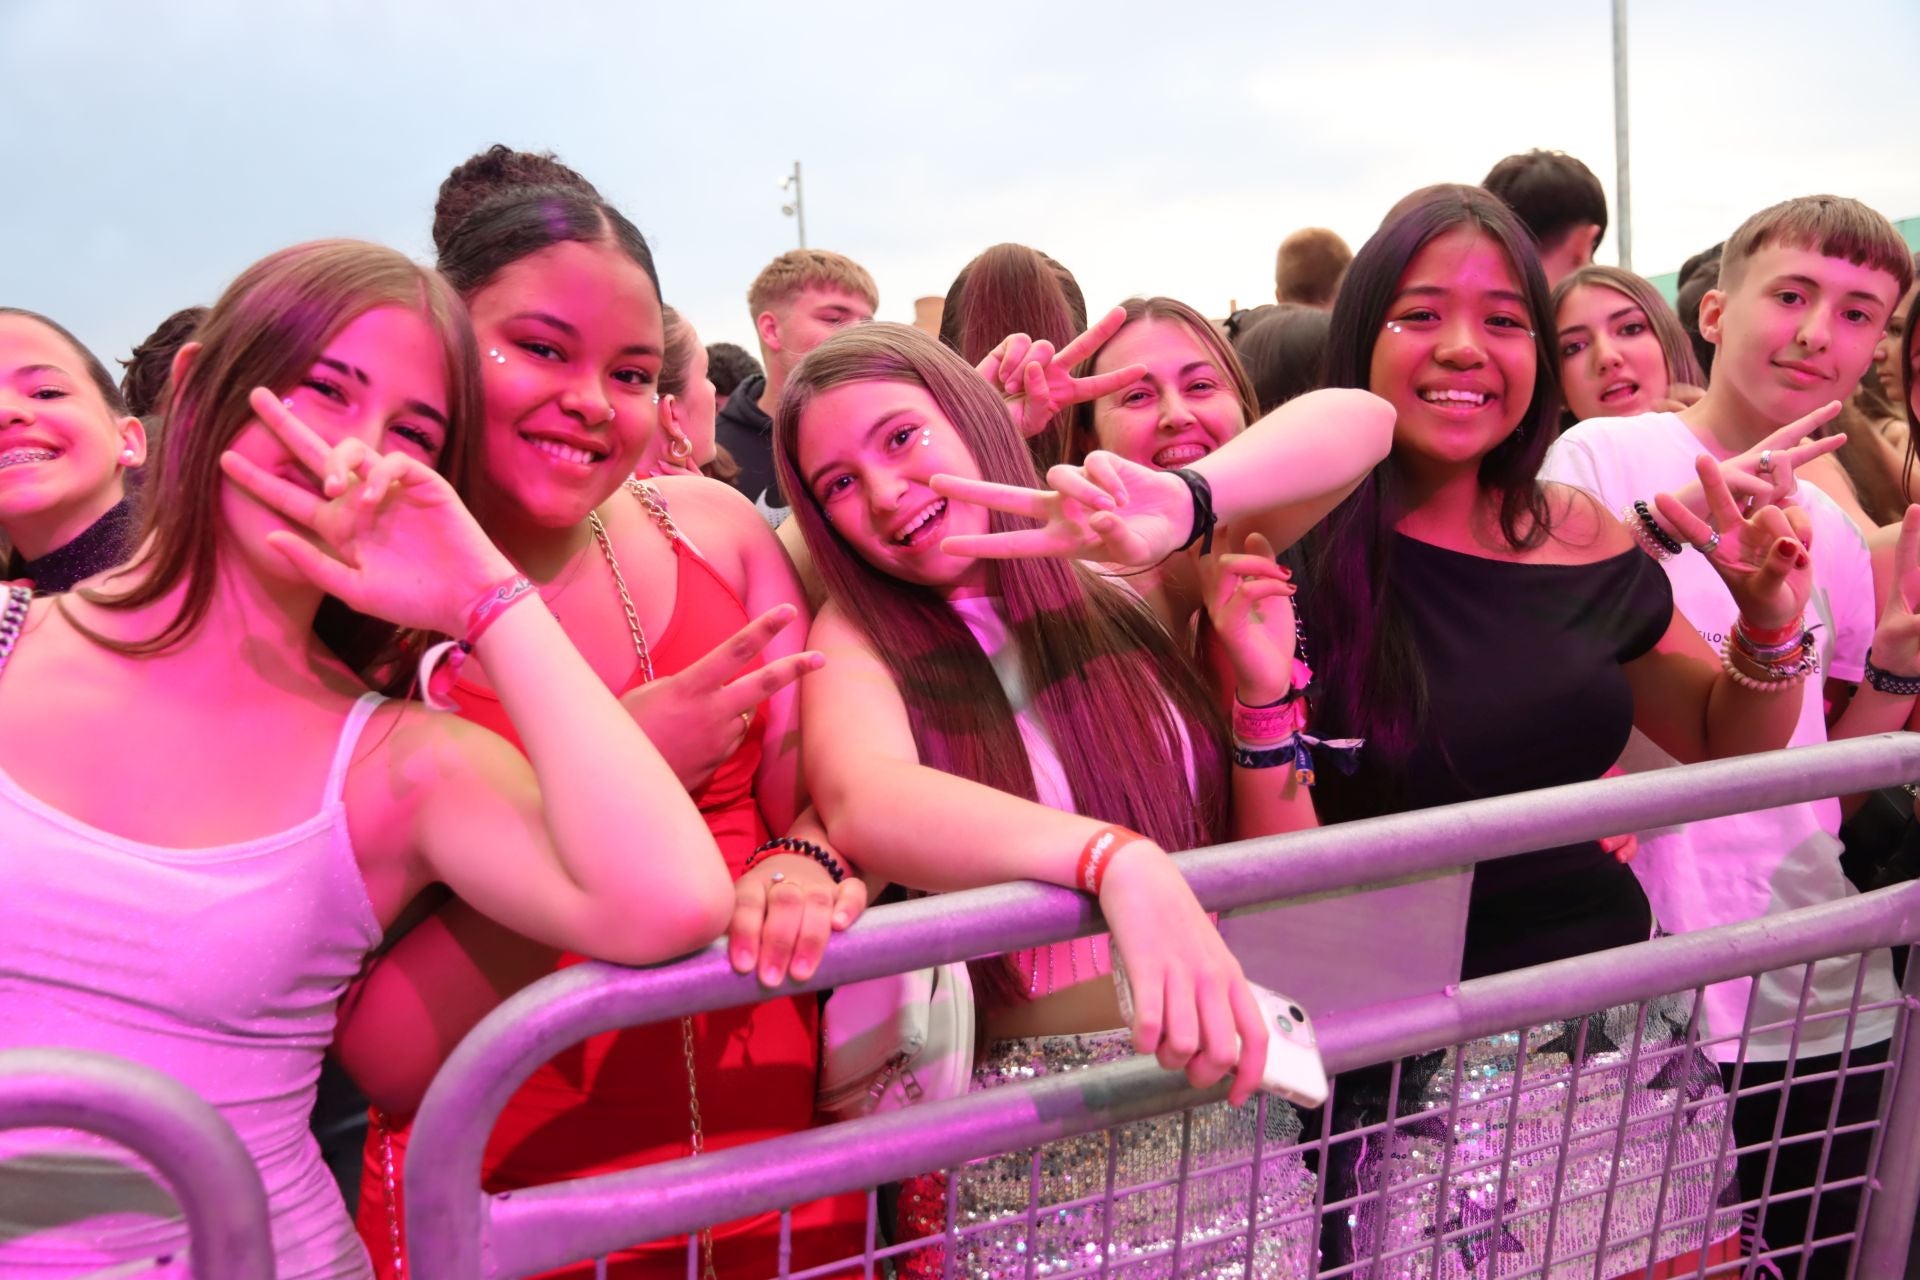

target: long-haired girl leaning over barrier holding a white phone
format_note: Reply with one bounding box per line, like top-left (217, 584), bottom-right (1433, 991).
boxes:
top-left (774, 324), bottom-right (1386, 1276)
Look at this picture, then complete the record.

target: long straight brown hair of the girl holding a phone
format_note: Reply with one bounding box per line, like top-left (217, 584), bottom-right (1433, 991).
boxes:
top-left (774, 324), bottom-right (1227, 924)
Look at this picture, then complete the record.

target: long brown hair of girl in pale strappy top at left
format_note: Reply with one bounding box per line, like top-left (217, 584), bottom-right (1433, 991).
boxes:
top-left (83, 240), bottom-right (480, 677)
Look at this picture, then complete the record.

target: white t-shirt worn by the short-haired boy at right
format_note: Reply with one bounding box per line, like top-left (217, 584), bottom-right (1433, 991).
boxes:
top-left (1540, 413), bottom-right (1899, 1061)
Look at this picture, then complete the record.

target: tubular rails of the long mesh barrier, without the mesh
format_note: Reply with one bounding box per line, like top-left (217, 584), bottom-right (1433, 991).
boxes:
top-left (407, 733), bottom-right (1920, 1276)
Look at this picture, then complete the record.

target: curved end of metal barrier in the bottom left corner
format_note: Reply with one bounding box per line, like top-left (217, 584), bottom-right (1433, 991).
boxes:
top-left (0, 1050), bottom-right (275, 1280)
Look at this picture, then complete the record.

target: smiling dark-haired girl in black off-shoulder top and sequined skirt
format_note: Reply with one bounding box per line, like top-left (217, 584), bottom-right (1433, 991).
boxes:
top-left (1306, 186), bottom-right (1811, 1276)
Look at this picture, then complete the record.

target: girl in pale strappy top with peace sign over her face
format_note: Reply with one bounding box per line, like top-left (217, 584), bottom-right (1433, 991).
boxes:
top-left (0, 242), bottom-right (733, 1280)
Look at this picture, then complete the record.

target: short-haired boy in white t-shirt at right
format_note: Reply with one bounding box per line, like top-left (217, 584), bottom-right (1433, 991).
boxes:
top-left (1540, 196), bottom-right (1920, 1276)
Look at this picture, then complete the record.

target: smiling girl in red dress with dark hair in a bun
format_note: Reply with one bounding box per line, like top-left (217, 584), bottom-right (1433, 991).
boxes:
top-left (340, 167), bottom-right (866, 1278)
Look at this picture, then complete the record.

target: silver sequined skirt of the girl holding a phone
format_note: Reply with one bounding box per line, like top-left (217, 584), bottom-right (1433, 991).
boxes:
top-left (900, 1031), bottom-right (1317, 1280)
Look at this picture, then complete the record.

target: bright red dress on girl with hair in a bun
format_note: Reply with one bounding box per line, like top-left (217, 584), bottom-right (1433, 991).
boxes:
top-left (357, 525), bottom-right (866, 1280)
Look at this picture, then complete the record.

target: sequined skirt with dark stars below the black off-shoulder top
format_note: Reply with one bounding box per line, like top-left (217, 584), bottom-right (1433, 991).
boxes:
top-left (1352, 996), bottom-right (1740, 1280)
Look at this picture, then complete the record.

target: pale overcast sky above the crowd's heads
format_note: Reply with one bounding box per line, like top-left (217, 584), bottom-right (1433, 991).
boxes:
top-left (0, 0), bottom-right (1920, 370)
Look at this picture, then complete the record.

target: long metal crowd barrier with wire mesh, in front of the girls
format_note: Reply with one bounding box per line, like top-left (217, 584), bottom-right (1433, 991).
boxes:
top-left (407, 733), bottom-right (1920, 1280)
